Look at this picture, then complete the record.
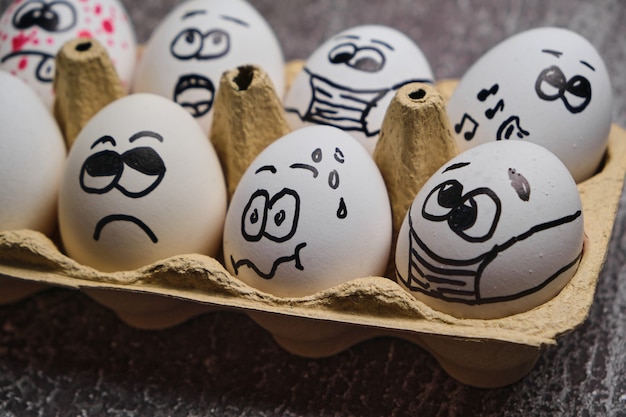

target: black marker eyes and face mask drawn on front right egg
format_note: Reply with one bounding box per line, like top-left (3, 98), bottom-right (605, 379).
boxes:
top-left (396, 165), bottom-right (582, 305)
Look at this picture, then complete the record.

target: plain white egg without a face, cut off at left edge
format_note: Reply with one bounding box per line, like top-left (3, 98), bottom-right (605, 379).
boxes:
top-left (0, 71), bottom-right (65, 234)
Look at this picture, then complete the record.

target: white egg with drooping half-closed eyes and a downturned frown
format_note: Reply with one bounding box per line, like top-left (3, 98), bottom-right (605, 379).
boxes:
top-left (59, 94), bottom-right (226, 271)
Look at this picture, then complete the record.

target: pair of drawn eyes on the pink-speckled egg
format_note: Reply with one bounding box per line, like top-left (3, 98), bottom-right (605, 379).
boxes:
top-left (13, 1), bottom-right (76, 32)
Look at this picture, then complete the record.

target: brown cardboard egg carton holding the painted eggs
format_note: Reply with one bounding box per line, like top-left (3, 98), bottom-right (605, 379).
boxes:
top-left (0, 39), bottom-right (626, 387)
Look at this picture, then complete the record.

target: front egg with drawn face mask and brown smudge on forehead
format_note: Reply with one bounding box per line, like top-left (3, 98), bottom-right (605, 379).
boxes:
top-left (395, 141), bottom-right (584, 318)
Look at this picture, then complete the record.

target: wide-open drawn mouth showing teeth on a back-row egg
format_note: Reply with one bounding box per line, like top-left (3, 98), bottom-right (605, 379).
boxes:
top-left (174, 74), bottom-right (215, 118)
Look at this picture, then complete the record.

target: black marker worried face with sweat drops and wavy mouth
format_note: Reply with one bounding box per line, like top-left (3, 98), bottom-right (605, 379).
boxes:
top-left (230, 148), bottom-right (348, 279)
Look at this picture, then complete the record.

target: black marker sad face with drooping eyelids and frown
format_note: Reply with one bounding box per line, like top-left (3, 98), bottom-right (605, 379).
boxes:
top-left (78, 131), bottom-right (166, 243)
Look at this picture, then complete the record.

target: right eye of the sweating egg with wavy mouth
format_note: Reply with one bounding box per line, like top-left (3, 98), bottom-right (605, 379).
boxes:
top-left (265, 189), bottom-right (300, 242)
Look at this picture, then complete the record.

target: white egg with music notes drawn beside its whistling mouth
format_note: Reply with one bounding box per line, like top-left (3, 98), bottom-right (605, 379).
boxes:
top-left (447, 27), bottom-right (612, 182)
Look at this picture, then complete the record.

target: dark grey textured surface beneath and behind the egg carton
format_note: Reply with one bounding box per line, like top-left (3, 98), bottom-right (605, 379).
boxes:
top-left (0, 0), bottom-right (626, 417)
